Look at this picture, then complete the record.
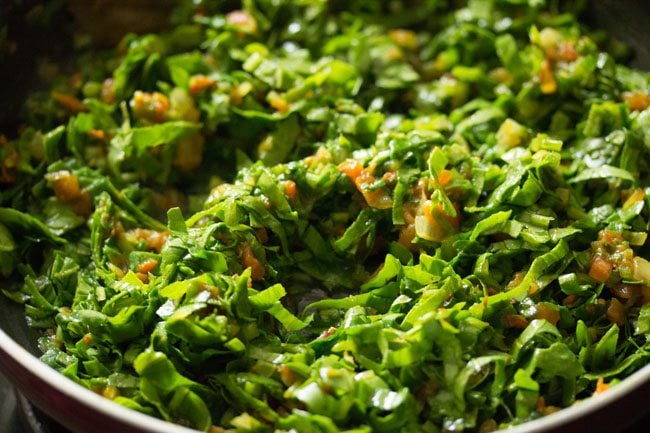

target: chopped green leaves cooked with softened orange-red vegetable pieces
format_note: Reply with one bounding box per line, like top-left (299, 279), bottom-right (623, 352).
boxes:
top-left (0, 0), bottom-right (650, 433)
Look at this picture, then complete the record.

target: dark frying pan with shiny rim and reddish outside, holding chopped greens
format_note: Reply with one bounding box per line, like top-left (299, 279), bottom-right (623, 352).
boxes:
top-left (0, 0), bottom-right (650, 433)
